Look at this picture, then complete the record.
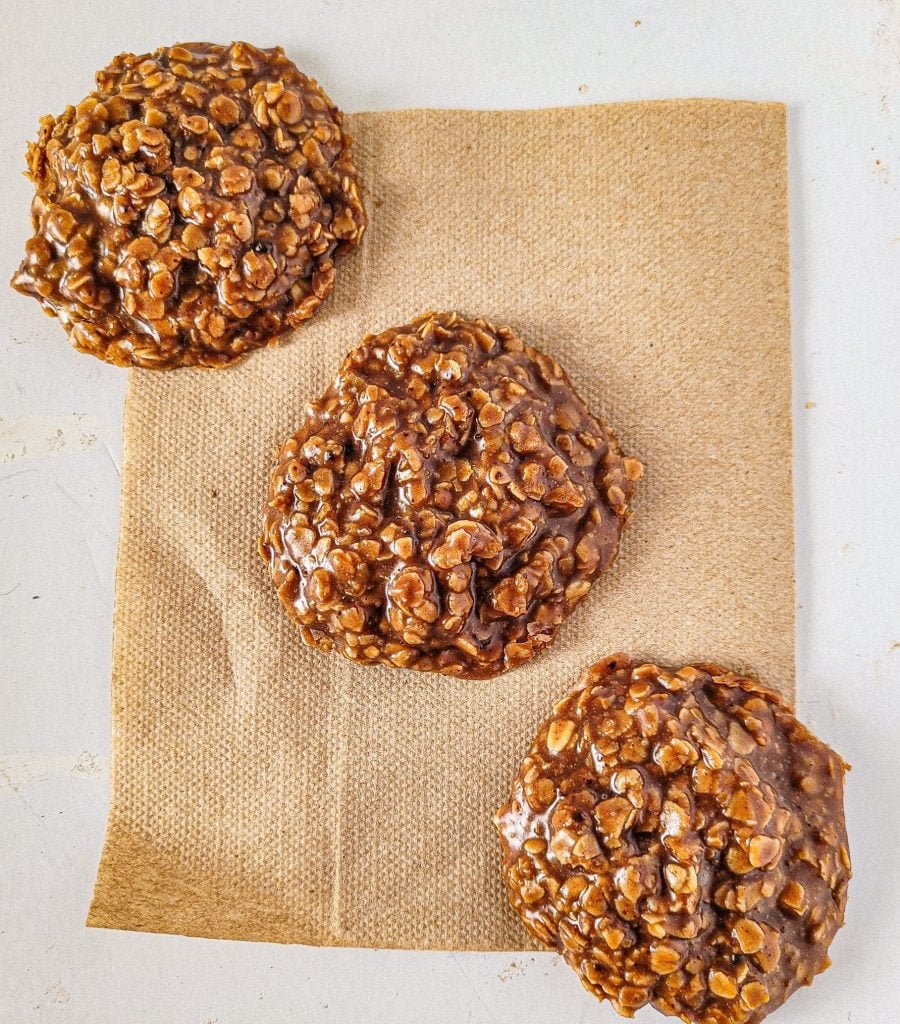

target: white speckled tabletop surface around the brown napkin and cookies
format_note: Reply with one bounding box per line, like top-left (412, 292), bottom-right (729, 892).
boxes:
top-left (0, 0), bottom-right (900, 1024)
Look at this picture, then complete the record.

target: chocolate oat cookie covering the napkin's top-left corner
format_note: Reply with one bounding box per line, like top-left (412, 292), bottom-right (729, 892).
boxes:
top-left (12, 43), bottom-right (366, 370)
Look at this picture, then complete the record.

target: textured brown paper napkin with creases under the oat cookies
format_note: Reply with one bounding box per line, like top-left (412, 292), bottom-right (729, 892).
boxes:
top-left (88, 100), bottom-right (794, 949)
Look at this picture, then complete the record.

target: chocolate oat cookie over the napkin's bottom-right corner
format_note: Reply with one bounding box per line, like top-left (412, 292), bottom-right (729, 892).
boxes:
top-left (495, 654), bottom-right (850, 1024)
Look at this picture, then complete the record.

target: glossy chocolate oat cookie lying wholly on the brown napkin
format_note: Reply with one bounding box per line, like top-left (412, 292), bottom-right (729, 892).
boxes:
top-left (260, 313), bottom-right (642, 678)
